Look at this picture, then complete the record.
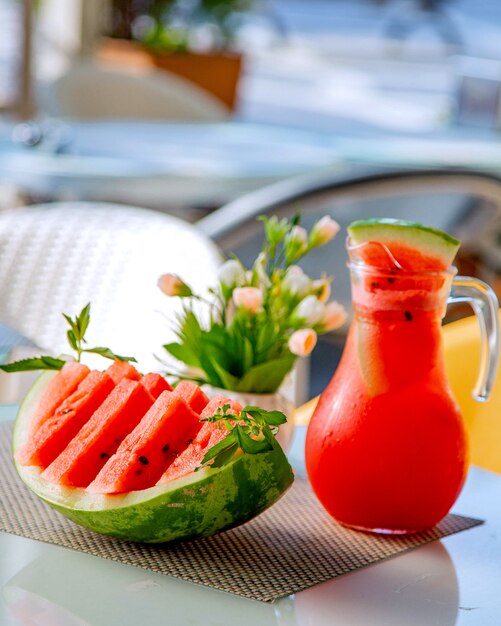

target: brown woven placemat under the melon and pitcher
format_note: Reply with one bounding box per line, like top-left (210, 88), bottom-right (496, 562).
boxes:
top-left (0, 424), bottom-right (482, 602)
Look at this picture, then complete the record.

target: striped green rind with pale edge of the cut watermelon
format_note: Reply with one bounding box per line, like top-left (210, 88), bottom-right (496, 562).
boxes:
top-left (13, 372), bottom-right (294, 543)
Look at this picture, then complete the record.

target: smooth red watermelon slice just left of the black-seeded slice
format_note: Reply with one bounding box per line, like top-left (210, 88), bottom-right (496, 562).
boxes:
top-left (42, 378), bottom-right (155, 487)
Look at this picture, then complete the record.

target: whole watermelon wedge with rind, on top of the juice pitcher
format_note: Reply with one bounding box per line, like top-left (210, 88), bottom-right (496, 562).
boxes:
top-left (348, 218), bottom-right (461, 272)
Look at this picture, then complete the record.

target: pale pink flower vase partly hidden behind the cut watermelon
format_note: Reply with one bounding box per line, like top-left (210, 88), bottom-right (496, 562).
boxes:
top-left (202, 385), bottom-right (295, 453)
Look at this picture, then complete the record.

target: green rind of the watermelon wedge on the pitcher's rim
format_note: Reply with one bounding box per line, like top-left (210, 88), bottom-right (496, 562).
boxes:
top-left (348, 218), bottom-right (461, 267)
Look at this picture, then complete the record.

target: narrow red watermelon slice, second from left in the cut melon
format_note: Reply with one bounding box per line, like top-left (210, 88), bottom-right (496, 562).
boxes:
top-left (18, 371), bottom-right (115, 468)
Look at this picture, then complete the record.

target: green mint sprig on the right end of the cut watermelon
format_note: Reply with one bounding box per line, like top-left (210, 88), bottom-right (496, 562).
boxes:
top-left (197, 404), bottom-right (287, 469)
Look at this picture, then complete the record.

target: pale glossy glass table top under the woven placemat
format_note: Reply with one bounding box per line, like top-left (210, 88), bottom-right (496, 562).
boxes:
top-left (0, 405), bottom-right (501, 626)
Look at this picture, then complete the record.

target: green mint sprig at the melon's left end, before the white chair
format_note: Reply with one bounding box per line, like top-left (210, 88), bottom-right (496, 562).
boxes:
top-left (0, 302), bottom-right (137, 373)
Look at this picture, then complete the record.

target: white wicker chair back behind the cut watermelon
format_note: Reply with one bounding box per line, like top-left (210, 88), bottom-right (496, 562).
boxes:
top-left (0, 202), bottom-right (219, 401)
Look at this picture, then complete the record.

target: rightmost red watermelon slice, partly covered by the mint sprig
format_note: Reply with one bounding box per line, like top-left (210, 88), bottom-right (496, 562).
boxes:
top-left (157, 395), bottom-right (242, 485)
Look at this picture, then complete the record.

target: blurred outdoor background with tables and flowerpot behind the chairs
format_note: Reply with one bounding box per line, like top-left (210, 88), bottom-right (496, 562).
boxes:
top-left (0, 0), bottom-right (501, 398)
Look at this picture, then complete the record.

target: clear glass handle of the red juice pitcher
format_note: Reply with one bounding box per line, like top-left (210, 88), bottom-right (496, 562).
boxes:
top-left (448, 276), bottom-right (499, 402)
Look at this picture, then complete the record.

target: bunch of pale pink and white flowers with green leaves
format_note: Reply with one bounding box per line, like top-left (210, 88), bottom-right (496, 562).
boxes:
top-left (158, 216), bottom-right (346, 393)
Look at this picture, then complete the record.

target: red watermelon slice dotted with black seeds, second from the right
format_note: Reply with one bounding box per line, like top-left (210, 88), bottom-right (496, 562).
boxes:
top-left (88, 391), bottom-right (201, 493)
